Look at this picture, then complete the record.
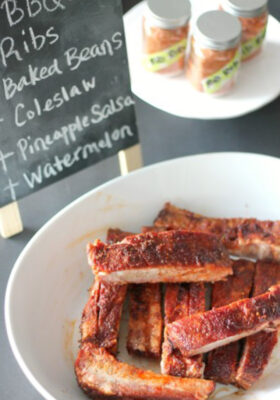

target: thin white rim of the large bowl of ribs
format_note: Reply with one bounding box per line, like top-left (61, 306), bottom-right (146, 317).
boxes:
top-left (4, 151), bottom-right (280, 400)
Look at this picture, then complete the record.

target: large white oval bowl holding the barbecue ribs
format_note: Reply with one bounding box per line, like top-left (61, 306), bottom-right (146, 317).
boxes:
top-left (5, 153), bottom-right (280, 400)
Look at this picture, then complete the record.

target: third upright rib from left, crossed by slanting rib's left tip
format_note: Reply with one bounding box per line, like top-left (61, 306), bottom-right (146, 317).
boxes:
top-left (161, 283), bottom-right (205, 378)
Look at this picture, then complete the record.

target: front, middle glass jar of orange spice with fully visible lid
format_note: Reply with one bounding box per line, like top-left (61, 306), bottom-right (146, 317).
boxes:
top-left (187, 10), bottom-right (241, 95)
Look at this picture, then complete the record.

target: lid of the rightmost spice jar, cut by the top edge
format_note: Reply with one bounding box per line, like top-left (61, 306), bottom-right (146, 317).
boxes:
top-left (222, 0), bottom-right (268, 18)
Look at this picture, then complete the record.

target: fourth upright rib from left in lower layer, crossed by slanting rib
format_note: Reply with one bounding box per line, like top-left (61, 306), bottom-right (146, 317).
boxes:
top-left (205, 260), bottom-right (255, 384)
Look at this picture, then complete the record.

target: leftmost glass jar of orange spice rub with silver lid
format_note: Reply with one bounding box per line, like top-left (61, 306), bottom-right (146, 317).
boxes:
top-left (143, 0), bottom-right (191, 75)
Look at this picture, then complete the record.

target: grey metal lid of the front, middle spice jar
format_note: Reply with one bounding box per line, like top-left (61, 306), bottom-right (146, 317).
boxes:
top-left (194, 10), bottom-right (242, 50)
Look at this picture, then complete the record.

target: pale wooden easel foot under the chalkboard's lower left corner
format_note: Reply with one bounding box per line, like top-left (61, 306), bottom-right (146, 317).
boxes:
top-left (0, 202), bottom-right (23, 239)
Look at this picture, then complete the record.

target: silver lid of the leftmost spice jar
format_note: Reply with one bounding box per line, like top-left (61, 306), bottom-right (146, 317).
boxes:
top-left (147, 0), bottom-right (191, 29)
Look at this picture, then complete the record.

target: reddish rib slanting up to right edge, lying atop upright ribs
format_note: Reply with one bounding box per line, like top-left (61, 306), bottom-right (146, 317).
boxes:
top-left (166, 285), bottom-right (280, 356)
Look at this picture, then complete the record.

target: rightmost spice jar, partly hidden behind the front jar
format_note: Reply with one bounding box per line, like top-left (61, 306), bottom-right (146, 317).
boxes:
top-left (221, 0), bottom-right (268, 61)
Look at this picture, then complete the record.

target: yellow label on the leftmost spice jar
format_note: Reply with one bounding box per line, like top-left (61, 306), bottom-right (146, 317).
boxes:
top-left (142, 39), bottom-right (187, 72)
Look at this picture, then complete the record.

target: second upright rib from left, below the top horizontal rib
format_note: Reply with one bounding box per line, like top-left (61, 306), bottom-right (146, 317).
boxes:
top-left (127, 283), bottom-right (163, 358)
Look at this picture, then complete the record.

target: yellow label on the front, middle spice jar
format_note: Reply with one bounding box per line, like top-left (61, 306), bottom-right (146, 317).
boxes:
top-left (201, 49), bottom-right (241, 94)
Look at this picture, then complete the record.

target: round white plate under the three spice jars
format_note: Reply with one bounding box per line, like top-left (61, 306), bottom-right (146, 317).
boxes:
top-left (124, 0), bottom-right (280, 119)
